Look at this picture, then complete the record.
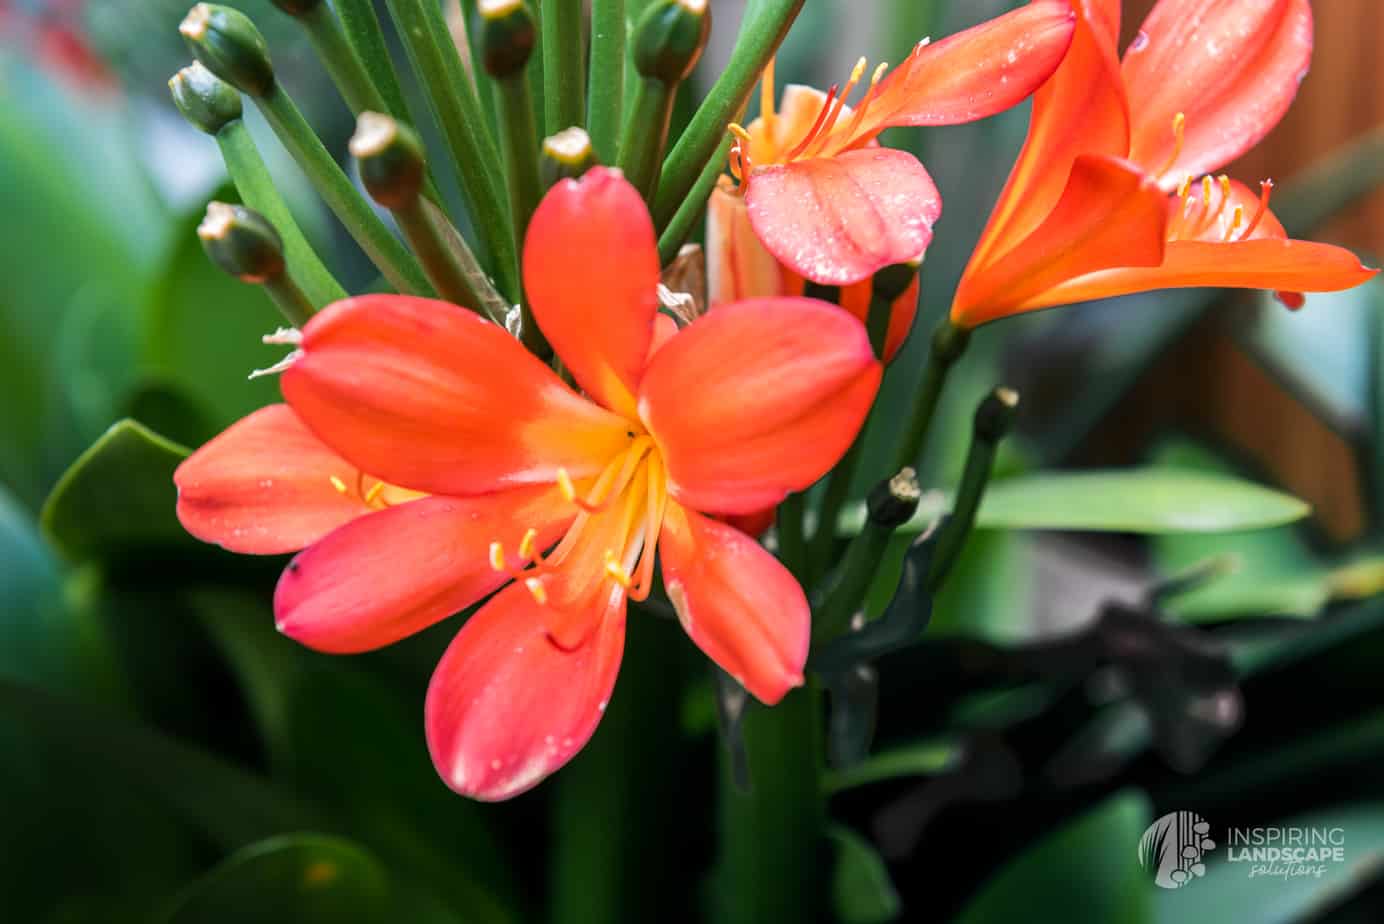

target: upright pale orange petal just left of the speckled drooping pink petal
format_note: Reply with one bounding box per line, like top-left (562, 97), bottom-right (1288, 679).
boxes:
top-left (706, 177), bottom-right (787, 307)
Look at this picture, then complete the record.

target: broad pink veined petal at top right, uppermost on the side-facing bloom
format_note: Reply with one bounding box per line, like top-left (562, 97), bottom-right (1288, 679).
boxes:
top-left (1124, 0), bottom-right (1312, 185)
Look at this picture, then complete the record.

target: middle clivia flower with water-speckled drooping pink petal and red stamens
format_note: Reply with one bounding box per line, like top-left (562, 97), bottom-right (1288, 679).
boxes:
top-left (707, 0), bottom-right (1073, 357)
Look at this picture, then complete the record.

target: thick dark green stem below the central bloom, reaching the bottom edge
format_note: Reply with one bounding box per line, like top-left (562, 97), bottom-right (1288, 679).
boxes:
top-left (716, 682), bottom-right (826, 924)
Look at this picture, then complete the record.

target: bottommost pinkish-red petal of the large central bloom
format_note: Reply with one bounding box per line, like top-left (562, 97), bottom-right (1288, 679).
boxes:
top-left (425, 584), bottom-right (624, 801)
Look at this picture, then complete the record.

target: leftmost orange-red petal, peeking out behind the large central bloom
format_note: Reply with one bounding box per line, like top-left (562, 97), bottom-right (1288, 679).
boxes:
top-left (173, 404), bottom-right (371, 555)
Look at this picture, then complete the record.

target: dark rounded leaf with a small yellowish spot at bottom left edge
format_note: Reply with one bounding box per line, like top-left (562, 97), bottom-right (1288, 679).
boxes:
top-left (163, 834), bottom-right (390, 924)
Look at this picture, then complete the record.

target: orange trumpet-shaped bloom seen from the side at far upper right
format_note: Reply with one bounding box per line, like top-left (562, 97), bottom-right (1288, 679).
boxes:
top-left (951, 0), bottom-right (1374, 328)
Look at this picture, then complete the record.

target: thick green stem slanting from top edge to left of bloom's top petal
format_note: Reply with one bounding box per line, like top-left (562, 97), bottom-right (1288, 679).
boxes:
top-left (389, 0), bottom-right (519, 299)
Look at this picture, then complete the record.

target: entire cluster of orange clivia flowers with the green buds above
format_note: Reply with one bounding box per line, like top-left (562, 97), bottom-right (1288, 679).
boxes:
top-left (174, 0), bottom-right (1372, 800)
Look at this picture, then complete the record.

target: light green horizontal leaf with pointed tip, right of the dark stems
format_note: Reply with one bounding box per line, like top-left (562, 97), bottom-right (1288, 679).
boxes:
top-left (839, 468), bottom-right (1312, 534)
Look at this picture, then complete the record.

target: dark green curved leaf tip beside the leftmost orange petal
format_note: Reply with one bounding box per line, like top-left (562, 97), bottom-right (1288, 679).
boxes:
top-left (40, 421), bottom-right (192, 560)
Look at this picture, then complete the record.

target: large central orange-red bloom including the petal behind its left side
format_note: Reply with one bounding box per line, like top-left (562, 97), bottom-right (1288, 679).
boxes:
top-left (167, 167), bottom-right (882, 800)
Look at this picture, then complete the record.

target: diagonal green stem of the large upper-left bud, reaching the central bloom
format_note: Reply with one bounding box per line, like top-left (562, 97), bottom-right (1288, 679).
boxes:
top-left (255, 86), bottom-right (433, 295)
